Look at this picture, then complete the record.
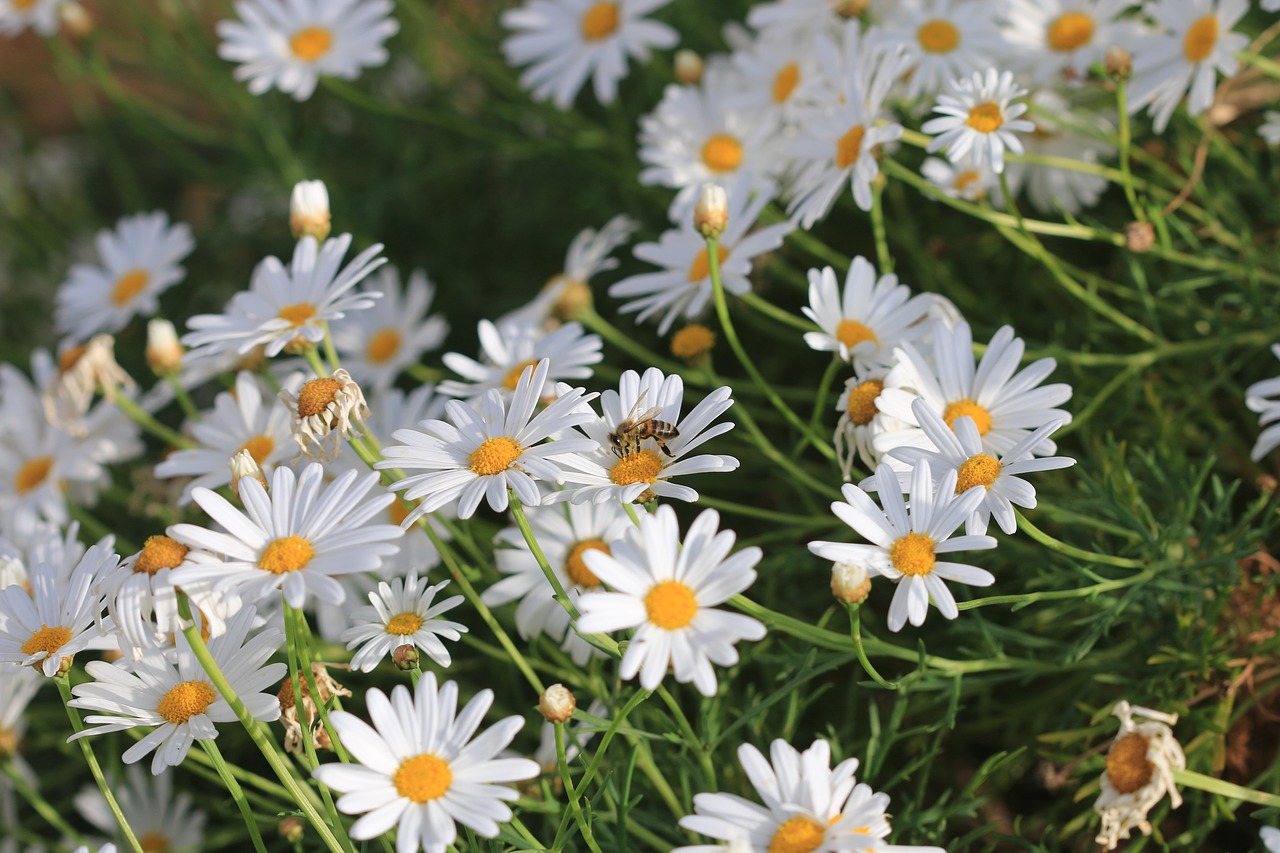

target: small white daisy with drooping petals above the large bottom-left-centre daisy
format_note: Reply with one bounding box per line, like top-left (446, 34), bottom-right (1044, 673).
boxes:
top-left (342, 571), bottom-right (467, 672)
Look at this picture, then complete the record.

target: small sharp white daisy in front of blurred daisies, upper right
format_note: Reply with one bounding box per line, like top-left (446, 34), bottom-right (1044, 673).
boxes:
top-left (920, 68), bottom-right (1036, 174)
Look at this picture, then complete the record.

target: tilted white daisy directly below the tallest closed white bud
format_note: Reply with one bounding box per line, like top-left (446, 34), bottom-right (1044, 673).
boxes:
top-left (182, 234), bottom-right (387, 357)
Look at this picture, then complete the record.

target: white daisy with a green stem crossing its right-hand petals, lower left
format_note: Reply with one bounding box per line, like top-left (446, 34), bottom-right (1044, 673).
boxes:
top-left (68, 607), bottom-right (288, 776)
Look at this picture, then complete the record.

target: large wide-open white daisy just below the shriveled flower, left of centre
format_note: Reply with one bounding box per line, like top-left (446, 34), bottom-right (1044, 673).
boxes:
top-left (166, 462), bottom-right (403, 607)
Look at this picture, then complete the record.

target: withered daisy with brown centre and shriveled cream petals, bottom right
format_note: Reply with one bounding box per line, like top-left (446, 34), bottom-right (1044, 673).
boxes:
top-left (1093, 699), bottom-right (1187, 850)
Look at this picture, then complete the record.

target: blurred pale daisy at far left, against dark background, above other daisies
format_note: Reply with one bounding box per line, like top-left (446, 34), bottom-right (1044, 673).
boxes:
top-left (54, 210), bottom-right (196, 342)
